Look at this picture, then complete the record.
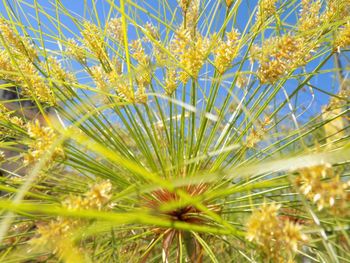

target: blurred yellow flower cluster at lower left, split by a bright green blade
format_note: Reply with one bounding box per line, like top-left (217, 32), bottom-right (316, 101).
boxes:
top-left (31, 180), bottom-right (112, 256)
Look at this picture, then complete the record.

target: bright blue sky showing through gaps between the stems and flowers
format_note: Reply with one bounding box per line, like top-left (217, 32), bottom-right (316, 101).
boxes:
top-left (0, 0), bottom-right (337, 125)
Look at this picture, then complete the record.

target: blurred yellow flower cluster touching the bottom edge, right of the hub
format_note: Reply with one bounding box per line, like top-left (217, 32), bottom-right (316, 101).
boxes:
top-left (246, 203), bottom-right (307, 262)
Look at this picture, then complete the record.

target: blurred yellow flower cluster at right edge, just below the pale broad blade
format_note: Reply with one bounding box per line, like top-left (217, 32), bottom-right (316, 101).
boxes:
top-left (296, 163), bottom-right (350, 215)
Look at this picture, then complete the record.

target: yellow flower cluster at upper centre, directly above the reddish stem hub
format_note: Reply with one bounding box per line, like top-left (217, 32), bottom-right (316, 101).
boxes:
top-left (171, 29), bottom-right (210, 83)
